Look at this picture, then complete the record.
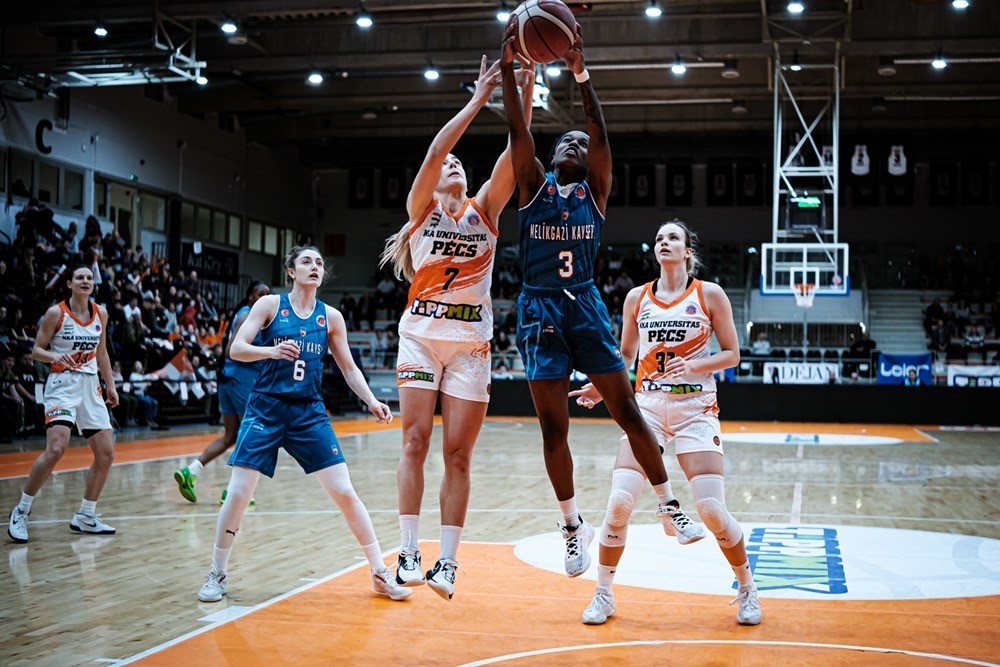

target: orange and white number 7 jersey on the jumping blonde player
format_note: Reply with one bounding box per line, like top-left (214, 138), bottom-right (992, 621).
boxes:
top-left (399, 199), bottom-right (498, 342)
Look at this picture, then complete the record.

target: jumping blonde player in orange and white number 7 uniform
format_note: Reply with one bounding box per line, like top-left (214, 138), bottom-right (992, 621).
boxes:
top-left (381, 56), bottom-right (534, 600)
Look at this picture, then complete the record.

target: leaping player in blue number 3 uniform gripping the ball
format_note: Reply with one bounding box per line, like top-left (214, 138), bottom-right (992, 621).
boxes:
top-left (500, 24), bottom-right (700, 577)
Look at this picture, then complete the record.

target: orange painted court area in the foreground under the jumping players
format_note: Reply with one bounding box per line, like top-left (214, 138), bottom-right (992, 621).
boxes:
top-left (139, 543), bottom-right (1000, 666)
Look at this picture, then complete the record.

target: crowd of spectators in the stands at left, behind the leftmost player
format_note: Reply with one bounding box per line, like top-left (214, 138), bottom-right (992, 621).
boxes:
top-left (0, 199), bottom-right (227, 440)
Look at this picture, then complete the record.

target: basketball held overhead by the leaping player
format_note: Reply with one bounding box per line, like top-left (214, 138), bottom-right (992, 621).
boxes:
top-left (508, 0), bottom-right (576, 64)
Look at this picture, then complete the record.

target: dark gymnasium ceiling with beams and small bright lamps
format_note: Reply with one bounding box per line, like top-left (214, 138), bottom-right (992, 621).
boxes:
top-left (0, 0), bottom-right (1000, 164)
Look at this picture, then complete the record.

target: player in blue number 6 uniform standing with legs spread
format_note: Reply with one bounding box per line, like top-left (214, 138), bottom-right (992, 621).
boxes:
top-left (198, 246), bottom-right (411, 602)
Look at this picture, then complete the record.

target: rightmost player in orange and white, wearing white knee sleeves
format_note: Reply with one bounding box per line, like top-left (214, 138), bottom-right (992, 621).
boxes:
top-left (569, 220), bottom-right (761, 625)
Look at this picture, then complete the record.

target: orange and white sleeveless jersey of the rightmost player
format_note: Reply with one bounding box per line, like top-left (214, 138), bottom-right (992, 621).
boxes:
top-left (633, 279), bottom-right (715, 395)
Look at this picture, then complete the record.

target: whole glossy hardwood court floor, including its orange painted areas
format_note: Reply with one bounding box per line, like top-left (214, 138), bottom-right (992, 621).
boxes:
top-left (0, 419), bottom-right (1000, 665)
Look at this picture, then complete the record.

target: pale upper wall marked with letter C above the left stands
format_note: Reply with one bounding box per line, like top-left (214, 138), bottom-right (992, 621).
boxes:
top-left (0, 86), bottom-right (312, 231)
